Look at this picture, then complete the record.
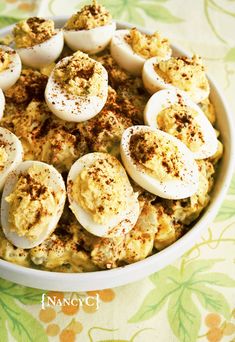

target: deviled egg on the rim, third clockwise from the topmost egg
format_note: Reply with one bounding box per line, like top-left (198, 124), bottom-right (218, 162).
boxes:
top-left (142, 55), bottom-right (210, 103)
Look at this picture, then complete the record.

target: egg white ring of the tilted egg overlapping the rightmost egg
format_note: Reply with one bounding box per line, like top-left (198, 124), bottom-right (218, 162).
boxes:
top-left (120, 126), bottom-right (199, 199)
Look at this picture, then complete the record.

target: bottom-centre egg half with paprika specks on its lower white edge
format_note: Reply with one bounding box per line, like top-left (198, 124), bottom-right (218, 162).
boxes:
top-left (67, 152), bottom-right (140, 237)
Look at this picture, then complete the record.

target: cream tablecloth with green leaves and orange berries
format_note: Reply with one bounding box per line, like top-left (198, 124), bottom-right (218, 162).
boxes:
top-left (0, 0), bottom-right (235, 342)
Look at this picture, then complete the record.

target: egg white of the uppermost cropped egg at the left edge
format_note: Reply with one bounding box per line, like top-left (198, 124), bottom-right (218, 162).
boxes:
top-left (0, 45), bottom-right (22, 91)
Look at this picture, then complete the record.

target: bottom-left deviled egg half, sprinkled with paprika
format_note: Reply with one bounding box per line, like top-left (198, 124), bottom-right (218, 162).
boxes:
top-left (1, 161), bottom-right (66, 249)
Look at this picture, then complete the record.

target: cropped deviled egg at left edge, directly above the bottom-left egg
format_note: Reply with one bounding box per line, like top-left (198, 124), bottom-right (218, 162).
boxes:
top-left (0, 127), bottom-right (23, 190)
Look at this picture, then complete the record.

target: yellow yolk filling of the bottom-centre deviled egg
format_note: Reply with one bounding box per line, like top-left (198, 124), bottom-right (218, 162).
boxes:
top-left (72, 155), bottom-right (130, 223)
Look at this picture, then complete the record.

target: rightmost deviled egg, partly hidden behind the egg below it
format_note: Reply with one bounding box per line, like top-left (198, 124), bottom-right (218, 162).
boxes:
top-left (144, 89), bottom-right (218, 159)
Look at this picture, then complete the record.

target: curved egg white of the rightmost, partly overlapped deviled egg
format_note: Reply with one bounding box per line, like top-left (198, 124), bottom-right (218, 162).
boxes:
top-left (144, 89), bottom-right (218, 159)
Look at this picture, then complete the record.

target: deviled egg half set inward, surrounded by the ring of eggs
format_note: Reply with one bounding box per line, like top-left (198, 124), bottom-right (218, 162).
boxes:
top-left (45, 52), bottom-right (108, 122)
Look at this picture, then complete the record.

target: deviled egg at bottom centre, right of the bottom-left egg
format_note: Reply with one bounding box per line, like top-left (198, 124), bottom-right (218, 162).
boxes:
top-left (67, 152), bottom-right (140, 237)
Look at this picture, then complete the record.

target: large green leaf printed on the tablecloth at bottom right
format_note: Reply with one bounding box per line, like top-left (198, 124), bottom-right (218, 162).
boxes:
top-left (129, 259), bottom-right (235, 342)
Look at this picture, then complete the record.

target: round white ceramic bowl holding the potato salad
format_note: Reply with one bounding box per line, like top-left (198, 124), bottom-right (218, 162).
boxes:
top-left (0, 17), bottom-right (234, 291)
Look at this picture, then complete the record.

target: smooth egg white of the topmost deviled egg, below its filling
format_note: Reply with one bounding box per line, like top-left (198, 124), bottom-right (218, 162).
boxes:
top-left (64, 22), bottom-right (116, 54)
